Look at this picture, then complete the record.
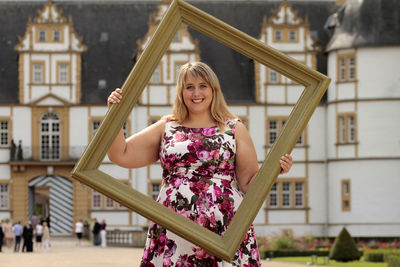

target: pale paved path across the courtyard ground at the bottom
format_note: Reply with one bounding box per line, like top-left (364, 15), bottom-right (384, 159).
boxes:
top-left (0, 238), bottom-right (305, 267)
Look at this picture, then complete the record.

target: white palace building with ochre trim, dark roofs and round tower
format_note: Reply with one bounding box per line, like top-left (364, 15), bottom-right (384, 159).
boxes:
top-left (0, 0), bottom-right (400, 237)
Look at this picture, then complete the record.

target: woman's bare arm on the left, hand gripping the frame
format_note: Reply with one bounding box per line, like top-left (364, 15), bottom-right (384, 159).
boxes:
top-left (107, 89), bottom-right (165, 168)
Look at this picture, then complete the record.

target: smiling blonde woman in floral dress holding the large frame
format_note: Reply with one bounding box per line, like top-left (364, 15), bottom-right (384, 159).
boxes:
top-left (107, 62), bottom-right (292, 266)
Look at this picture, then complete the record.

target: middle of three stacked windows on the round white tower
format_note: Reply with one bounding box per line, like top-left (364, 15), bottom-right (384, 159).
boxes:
top-left (337, 113), bottom-right (357, 143)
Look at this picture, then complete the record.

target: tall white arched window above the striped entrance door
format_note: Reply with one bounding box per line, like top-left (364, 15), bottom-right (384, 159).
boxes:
top-left (40, 112), bottom-right (61, 160)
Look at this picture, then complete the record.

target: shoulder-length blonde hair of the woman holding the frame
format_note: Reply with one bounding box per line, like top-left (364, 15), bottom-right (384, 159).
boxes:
top-left (168, 62), bottom-right (236, 130)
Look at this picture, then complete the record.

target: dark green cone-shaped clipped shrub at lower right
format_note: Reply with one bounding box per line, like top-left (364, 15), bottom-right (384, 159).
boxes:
top-left (329, 227), bottom-right (361, 262)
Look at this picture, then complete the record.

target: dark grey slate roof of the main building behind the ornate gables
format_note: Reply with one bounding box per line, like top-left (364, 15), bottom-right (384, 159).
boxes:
top-left (0, 1), bottom-right (336, 104)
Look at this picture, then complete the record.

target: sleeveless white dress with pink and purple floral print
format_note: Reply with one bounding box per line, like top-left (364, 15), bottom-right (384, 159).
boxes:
top-left (140, 119), bottom-right (261, 267)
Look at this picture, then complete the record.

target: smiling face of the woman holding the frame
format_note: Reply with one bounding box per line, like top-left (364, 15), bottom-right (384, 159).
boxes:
top-left (182, 74), bottom-right (213, 118)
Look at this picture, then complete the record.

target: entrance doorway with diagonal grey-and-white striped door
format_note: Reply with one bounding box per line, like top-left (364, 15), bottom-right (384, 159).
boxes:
top-left (29, 175), bottom-right (73, 235)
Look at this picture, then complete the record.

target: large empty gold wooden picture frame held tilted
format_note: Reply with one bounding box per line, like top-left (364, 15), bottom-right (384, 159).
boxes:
top-left (72, 0), bottom-right (330, 261)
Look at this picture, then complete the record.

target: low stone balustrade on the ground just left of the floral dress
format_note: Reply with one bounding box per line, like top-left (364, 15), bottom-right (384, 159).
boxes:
top-left (107, 230), bottom-right (147, 248)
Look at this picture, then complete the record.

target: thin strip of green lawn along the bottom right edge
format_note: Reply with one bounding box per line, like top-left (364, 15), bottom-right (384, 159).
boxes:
top-left (273, 257), bottom-right (387, 267)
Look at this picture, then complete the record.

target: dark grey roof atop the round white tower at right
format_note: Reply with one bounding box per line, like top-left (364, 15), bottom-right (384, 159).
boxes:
top-left (326, 0), bottom-right (400, 51)
